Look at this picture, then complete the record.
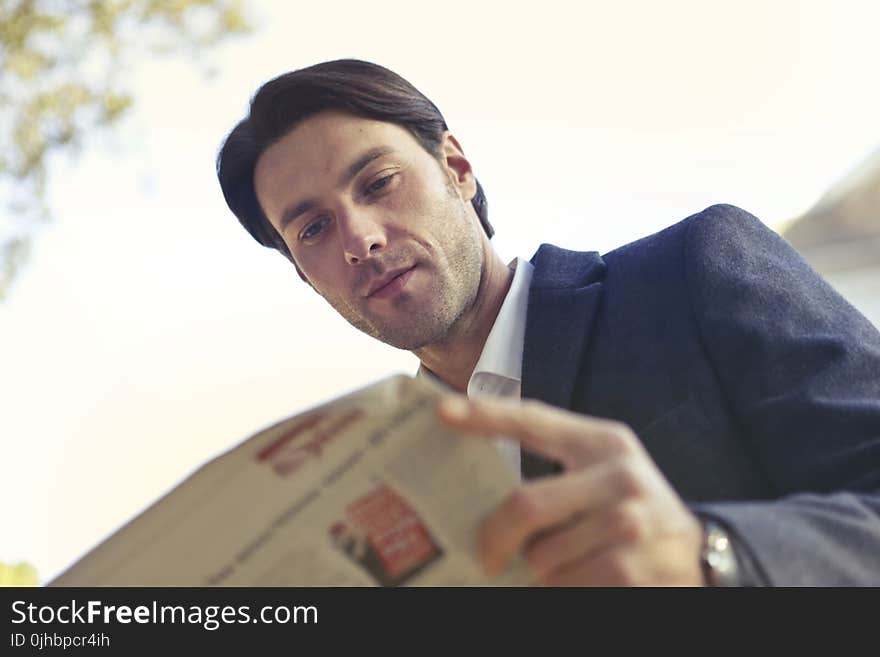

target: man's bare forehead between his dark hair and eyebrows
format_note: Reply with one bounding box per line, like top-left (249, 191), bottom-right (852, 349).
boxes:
top-left (254, 111), bottom-right (421, 197)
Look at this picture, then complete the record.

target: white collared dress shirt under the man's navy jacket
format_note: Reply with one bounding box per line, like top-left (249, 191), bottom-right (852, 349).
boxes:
top-left (416, 258), bottom-right (534, 477)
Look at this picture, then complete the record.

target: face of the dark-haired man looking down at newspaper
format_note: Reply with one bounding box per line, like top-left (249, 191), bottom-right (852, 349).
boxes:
top-left (254, 112), bottom-right (486, 350)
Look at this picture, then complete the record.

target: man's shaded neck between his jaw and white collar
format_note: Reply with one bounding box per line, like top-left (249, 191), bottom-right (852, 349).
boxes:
top-left (413, 244), bottom-right (513, 393)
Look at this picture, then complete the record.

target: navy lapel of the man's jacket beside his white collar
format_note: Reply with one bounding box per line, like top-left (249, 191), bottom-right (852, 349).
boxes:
top-left (521, 244), bottom-right (605, 478)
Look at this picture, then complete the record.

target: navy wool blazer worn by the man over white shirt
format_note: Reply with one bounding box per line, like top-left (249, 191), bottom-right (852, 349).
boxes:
top-left (522, 205), bottom-right (880, 586)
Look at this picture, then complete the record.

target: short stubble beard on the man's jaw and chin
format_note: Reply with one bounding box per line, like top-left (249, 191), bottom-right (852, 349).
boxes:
top-left (324, 190), bottom-right (483, 351)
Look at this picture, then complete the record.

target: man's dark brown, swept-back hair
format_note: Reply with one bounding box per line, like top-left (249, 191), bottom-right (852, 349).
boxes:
top-left (217, 59), bottom-right (495, 261)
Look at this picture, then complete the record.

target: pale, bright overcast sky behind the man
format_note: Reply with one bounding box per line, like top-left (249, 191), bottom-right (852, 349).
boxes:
top-left (0, 0), bottom-right (880, 581)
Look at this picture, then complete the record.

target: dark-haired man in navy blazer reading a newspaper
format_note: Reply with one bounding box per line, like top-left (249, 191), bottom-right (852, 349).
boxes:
top-left (218, 60), bottom-right (880, 585)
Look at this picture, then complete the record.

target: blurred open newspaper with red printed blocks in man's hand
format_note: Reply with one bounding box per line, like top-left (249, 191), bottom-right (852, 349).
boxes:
top-left (49, 375), bottom-right (532, 586)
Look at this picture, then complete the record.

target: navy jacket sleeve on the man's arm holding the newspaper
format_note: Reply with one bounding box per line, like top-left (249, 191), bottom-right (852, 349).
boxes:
top-left (684, 205), bottom-right (880, 586)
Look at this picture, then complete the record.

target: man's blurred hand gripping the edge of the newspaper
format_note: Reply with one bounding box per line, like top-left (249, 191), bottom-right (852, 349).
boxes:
top-left (437, 396), bottom-right (704, 586)
